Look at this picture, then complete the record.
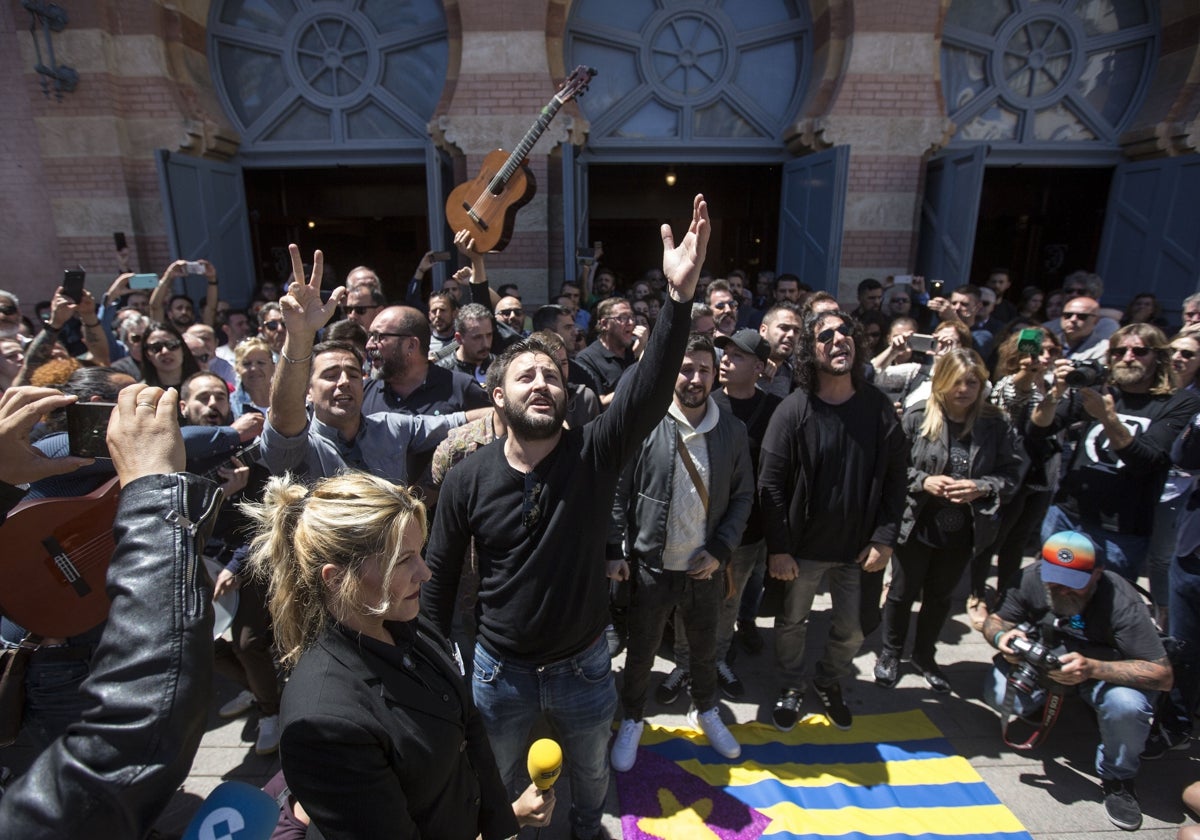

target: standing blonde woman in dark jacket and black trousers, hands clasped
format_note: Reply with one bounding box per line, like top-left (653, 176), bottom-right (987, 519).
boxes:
top-left (875, 348), bottom-right (1020, 692)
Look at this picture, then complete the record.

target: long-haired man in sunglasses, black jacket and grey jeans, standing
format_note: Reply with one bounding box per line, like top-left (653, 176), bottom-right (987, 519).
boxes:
top-left (758, 310), bottom-right (908, 732)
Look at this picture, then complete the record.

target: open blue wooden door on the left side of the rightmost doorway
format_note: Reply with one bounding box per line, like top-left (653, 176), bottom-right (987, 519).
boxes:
top-left (917, 144), bottom-right (988, 288)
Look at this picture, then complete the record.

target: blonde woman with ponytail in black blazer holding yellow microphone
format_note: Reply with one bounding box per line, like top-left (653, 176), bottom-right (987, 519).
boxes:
top-left (244, 472), bottom-right (553, 840)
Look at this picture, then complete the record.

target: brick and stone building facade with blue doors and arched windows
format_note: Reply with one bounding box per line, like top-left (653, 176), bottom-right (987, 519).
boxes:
top-left (0, 0), bottom-right (1200, 311)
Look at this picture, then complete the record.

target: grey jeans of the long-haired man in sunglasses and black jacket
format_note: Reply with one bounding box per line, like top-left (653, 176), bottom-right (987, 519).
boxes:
top-left (775, 560), bottom-right (863, 689)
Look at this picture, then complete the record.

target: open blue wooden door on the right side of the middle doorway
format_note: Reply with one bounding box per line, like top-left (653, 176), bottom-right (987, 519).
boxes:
top-left (775, 146), bottom-right (850, 295)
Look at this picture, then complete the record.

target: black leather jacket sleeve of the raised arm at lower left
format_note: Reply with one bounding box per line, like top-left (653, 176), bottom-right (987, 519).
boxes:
top-left (0, 473), bottom-right (222, 840)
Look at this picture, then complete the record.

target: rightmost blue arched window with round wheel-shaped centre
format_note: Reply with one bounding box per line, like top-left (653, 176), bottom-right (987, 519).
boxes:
top-left (942, 0), bottom-right (1158, 145)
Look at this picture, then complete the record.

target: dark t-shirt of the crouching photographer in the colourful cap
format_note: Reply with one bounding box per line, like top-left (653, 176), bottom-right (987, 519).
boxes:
top-left (997, 560), bottom-right (1166, 662)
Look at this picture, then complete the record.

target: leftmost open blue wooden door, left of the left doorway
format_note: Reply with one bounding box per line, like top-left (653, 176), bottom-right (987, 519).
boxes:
top-left (155, 149), bottom-right (256, 307)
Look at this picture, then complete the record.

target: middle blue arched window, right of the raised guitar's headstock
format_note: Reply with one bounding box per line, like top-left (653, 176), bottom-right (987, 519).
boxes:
top-left (564, 0), bottom-right (812, 153)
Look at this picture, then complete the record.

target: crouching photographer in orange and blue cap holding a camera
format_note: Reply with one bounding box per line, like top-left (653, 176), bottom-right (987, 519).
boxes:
top-left (983, 530), bottom-right (1174, 830)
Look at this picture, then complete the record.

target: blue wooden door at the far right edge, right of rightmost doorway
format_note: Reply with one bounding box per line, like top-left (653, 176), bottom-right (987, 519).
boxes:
top-left (1096, 155), bottom-right (1200, 312)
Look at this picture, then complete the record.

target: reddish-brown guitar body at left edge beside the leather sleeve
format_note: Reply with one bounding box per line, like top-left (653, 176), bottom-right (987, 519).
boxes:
top-left (0, 478), bottom-right (121, 637)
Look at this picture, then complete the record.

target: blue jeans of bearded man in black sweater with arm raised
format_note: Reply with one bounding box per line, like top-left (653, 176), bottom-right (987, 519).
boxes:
top-left (472, 635), bottom-right (617, 838)
